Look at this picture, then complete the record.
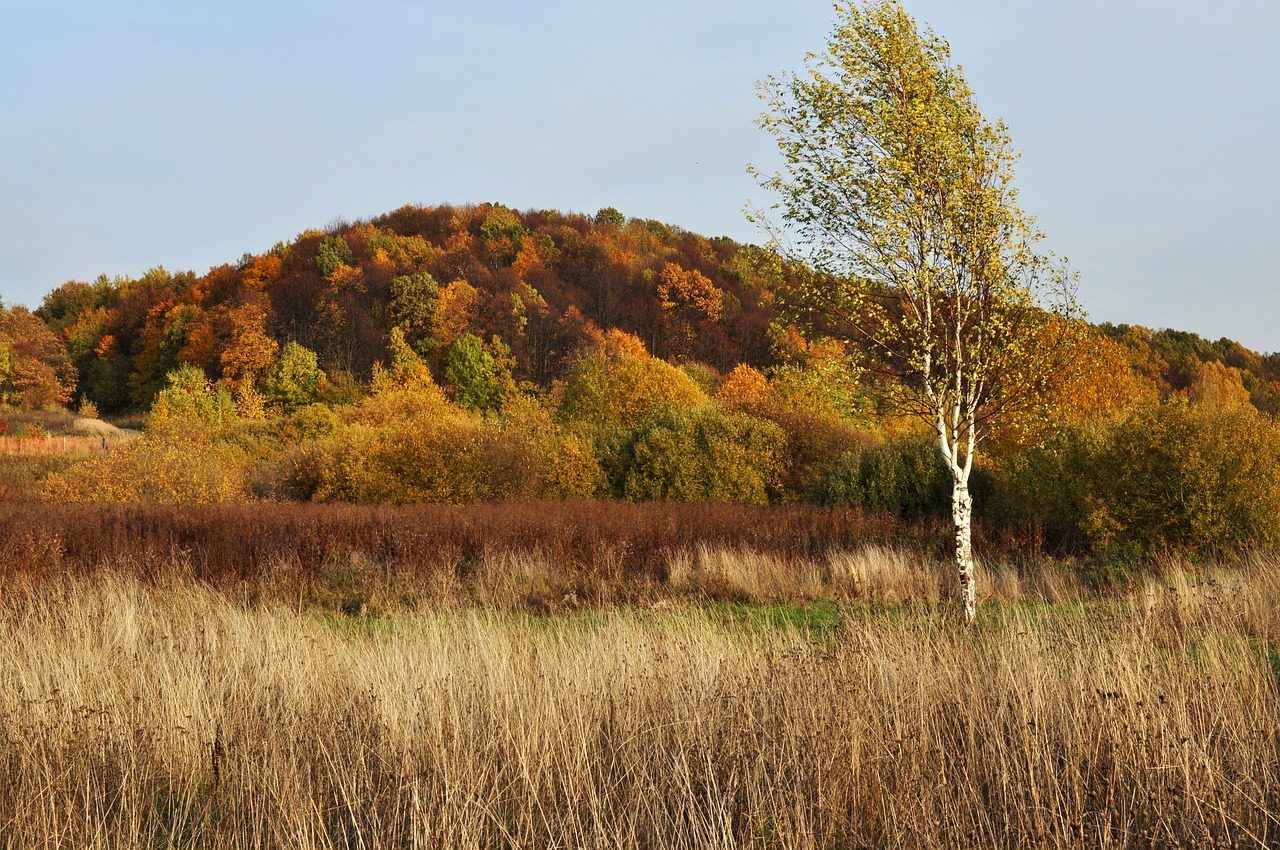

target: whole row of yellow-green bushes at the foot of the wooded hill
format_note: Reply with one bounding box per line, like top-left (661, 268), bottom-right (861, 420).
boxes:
top-left (41, 332), bottom-right (1280, 570)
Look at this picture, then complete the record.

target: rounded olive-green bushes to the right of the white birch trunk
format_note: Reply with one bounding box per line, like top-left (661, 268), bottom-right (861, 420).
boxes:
top-left (993, 398), bottom-right (1280, 554)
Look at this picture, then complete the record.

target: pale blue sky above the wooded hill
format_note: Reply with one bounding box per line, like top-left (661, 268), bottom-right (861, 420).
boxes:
top-left (0, 0), bottom-right (1280, 351)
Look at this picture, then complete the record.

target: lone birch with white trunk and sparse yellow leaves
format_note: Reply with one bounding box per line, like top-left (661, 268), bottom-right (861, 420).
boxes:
top-left (749, 0), bottom-right (1075, 622)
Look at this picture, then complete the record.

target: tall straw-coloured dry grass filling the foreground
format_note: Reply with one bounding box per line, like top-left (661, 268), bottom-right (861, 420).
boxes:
top-left (0, 553), bottom-right (1280, 847)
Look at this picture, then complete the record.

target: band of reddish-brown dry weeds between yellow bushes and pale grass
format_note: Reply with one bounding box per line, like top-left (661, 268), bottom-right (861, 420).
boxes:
top-left (0, 502), bottom-right (932, 607)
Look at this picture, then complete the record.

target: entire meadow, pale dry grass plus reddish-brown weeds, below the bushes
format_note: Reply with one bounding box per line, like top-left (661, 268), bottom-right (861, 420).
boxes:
top-left (0, 506), bottom-right (1280, 847)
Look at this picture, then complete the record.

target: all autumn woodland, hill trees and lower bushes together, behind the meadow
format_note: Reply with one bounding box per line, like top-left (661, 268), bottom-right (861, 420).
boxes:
top-left (0, 204), bottom-right (1280, 556)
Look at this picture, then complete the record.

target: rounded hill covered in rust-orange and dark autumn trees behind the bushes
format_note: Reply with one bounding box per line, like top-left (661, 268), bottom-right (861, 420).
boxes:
top-left (15, 198), bottom-right (1280, 413)
